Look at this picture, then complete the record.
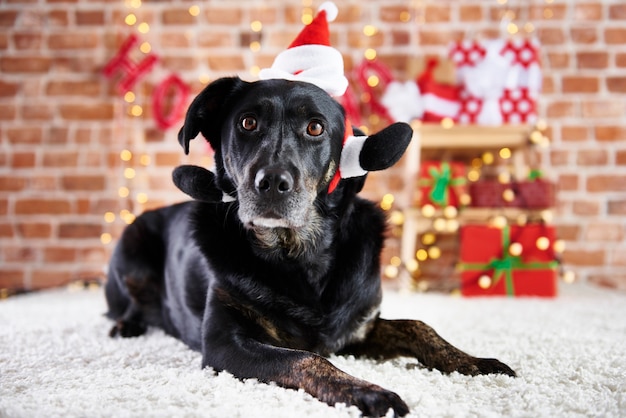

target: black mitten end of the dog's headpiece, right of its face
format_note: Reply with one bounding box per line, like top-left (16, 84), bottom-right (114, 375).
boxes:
top-left (359, 122), bottom-right (413, 171)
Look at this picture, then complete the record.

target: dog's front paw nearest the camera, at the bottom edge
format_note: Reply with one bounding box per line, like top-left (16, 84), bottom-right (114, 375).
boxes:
top-left (340, 385), bottom-right (409, 417)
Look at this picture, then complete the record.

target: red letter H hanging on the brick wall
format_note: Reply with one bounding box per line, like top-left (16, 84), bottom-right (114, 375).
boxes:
top-left (102, 35), bottom-right (158, 94)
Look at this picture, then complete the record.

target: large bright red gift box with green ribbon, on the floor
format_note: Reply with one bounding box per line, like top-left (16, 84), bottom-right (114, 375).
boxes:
top-left (460, 224), bottom-right (558, 297)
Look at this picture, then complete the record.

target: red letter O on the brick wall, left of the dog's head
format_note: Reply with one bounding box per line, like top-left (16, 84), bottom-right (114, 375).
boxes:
top-left (152, 74), bottom-right (189, 129)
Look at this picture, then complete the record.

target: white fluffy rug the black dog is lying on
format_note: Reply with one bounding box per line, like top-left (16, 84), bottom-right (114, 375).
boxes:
top-left (0, 285), bottom-right (626, 418)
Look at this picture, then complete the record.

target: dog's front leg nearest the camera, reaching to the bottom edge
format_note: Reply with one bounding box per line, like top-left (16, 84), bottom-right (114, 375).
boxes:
top-left (203, 335), bottom-right (409, 416)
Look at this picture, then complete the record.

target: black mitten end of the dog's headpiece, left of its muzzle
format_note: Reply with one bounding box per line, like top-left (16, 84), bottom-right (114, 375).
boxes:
top-left (172, 165), bottom-right (223, 202)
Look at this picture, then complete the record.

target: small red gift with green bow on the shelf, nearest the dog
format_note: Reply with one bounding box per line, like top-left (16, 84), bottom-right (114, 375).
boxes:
top-left (418, 161), bottom-right (469, 208)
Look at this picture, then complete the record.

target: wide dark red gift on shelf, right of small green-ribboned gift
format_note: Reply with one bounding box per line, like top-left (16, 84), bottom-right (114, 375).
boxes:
top-left (469, 179), bottom-right (555, 209)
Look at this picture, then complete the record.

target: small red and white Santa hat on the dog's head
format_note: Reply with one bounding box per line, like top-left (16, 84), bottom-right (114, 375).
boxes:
top-left (259, 1), bottom-right (348, 96)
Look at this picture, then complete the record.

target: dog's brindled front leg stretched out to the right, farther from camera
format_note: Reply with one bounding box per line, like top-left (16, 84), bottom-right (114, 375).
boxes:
top-left (343, 318), bottom-right (515, 376)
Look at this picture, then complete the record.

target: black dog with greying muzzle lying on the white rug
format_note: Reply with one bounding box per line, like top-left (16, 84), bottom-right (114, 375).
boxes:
top-left (106, 78), bottom-right (515, 416)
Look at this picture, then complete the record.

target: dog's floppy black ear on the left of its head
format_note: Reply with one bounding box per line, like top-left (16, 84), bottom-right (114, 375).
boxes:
top-left (178, 77), bottom-right (247, 154)
